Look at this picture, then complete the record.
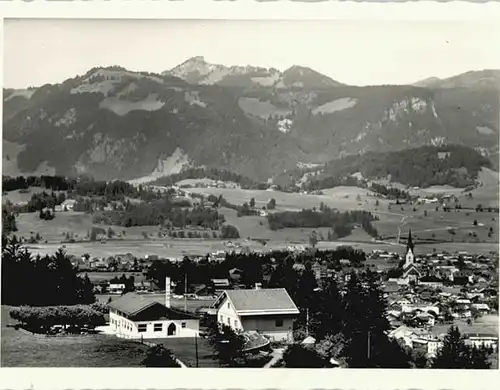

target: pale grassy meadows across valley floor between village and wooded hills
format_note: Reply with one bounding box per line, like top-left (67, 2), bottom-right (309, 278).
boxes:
top-left (9, 184), bottom-right (498, 258)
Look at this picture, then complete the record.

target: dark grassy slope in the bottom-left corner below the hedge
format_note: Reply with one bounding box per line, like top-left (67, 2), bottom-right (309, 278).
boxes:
top-left (1, 306), bottom-right (147, 367)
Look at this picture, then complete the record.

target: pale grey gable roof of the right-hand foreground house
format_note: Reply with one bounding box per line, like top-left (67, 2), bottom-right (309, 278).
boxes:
top-left (214, 288), bottom-right (299, 316)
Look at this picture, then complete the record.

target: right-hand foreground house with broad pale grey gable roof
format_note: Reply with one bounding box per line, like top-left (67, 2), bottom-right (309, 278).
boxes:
top-left (212, 288), bottom-right (299, 342)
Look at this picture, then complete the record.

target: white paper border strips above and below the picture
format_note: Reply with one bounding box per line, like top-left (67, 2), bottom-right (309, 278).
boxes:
top-left (0, 0), bottom-right (500, 390)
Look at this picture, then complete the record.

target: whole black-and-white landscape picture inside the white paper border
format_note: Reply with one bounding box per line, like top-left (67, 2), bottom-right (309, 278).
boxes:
top-left (1, 4), bottom-right (500, 374)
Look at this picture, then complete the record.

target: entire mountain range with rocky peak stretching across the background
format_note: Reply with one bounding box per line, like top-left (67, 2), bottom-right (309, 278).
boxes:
top-left (3, 63), bottom-right (499, 181)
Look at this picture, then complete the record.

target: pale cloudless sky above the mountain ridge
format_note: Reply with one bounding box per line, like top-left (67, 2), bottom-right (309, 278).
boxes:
top-left (3, 19), bottom-right (500, 88)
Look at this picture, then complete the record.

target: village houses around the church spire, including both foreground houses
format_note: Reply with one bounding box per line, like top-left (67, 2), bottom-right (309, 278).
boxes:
top-left (35, 227), bottom-right (492, 366)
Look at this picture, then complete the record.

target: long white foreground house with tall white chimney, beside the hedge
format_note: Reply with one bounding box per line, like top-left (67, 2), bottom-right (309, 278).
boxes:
top-left (108, 278), bottom-right (200, 339)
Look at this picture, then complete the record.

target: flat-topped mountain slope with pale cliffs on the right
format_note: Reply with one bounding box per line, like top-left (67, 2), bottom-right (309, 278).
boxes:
top-left (239, 82), bottom-right (499, 163)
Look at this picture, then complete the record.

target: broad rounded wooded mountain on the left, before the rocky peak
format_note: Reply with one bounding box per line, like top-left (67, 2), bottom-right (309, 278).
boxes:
top-left (4, 69), bottom-right (300, 179)
